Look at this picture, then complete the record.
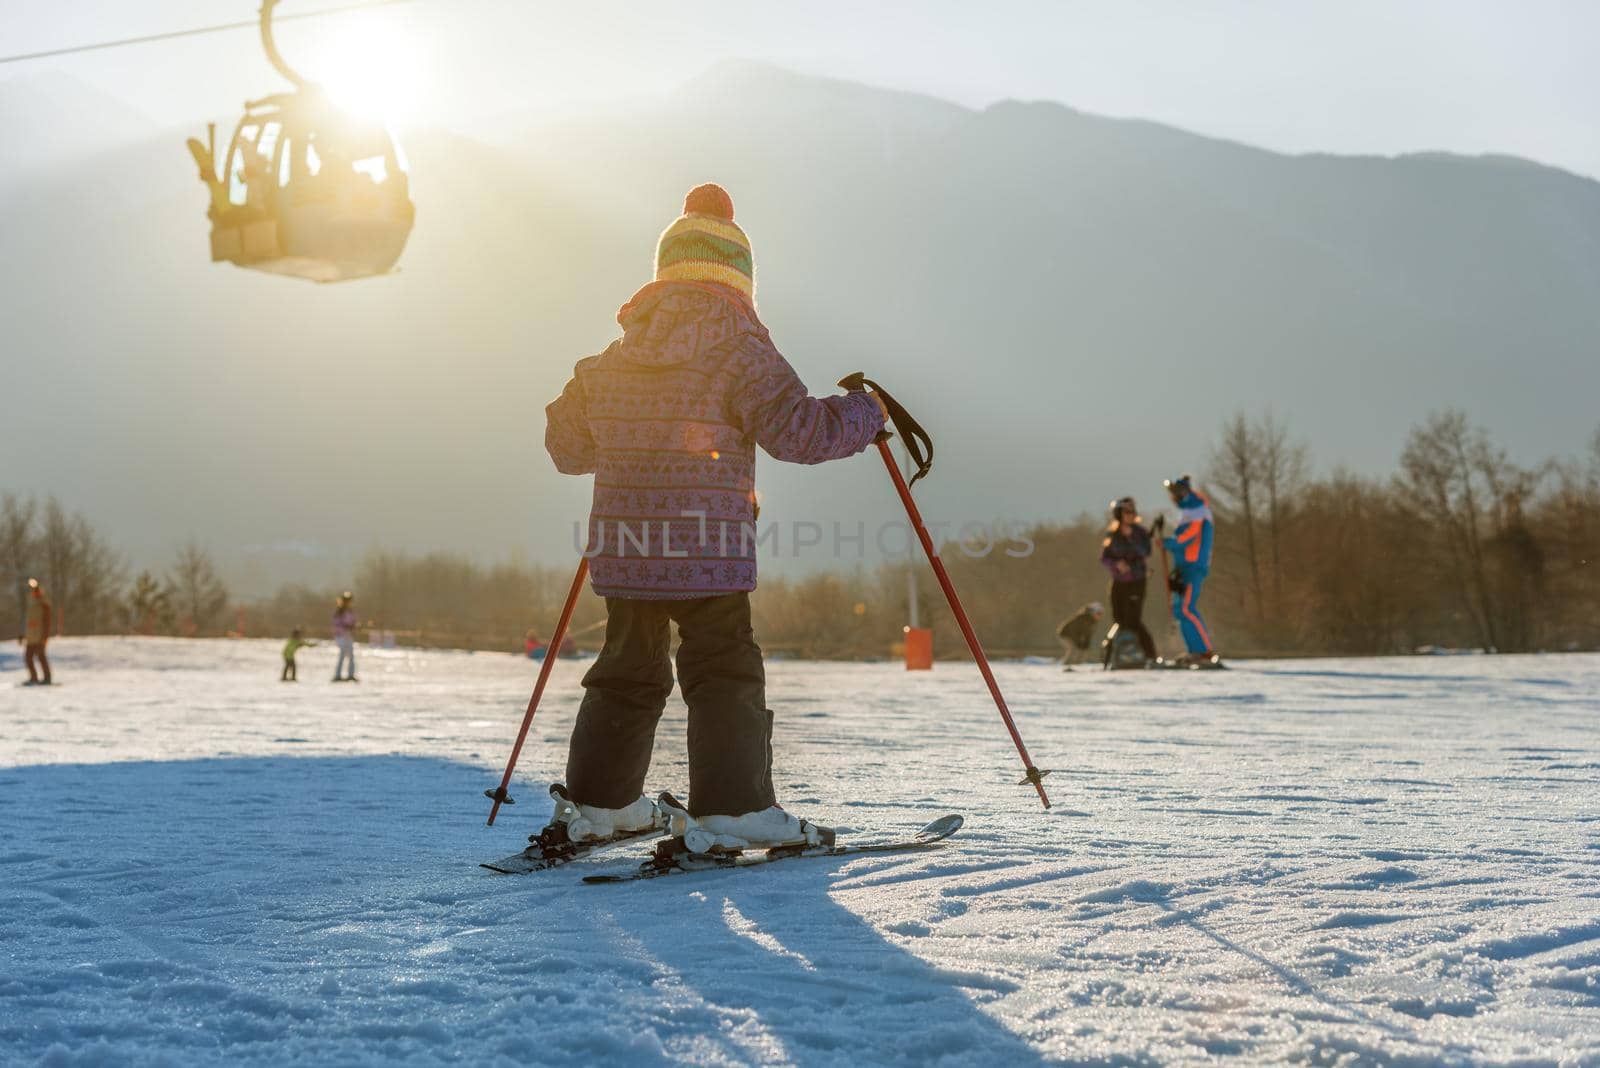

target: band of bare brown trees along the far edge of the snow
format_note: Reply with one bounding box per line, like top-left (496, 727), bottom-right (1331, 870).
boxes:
top-left (0, 411), bottom-right (1600, 659)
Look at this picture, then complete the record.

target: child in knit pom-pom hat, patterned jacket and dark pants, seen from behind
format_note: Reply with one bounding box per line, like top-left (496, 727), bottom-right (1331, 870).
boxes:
top-left (541, 185), bottom-right (885, 852)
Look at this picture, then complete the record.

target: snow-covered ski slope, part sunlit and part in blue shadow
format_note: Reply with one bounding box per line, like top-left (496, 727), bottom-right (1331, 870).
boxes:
top-left (0, 640), bottom-right (1600, 1065)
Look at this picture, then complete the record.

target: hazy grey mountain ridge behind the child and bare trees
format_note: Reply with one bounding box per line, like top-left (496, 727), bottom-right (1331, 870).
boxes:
top-left (0, 64), bottom-right (1600, 588)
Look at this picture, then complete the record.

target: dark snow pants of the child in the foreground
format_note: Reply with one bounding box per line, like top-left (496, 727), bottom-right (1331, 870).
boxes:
top-left (566, 593), bottom-right (776, 815)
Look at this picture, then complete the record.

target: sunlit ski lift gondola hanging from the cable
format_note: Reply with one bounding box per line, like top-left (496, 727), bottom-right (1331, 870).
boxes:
top-left (189, 0), bottom-right (416, 281)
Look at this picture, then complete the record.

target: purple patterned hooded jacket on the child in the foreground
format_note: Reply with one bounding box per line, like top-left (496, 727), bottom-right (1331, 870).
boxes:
top-left (544, 281), bottom-right (883, 600)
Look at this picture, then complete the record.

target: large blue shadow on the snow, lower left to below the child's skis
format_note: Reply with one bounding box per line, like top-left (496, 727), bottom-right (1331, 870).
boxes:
top-left (0, 754), bottom-right (1040, 1065)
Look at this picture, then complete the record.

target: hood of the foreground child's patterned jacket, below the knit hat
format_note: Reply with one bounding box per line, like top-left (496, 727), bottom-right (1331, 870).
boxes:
top-left (616, 281), bottom-right (768, 368)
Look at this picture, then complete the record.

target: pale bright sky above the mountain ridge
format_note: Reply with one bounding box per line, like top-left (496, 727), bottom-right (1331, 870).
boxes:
top-left (0, 0), bottom-right (1600, 176)
